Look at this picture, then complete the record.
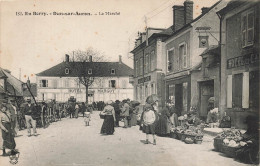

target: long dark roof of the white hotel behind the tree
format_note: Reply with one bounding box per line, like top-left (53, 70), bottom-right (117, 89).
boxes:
top-left (36, 62), bottom-right (134, 77)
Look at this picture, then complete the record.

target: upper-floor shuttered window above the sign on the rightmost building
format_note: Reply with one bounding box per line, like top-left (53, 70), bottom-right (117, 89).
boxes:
top-left (241, 9), bottom-right (254, 47)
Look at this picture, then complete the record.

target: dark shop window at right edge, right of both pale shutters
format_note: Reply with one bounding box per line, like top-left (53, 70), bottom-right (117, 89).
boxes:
top-left (249, 71), bottom-right (259, 111)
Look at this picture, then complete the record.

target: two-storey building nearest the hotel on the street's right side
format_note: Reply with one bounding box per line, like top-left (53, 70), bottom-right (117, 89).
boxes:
top-left (131, 28), bottom-right (168, 105)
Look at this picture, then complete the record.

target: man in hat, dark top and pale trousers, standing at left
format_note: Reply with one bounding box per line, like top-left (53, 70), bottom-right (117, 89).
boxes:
top-left (24, 99), bottom-right (37, 137)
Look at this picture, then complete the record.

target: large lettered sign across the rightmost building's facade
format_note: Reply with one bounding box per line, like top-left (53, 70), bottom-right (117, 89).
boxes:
top-left (227, 54), bottom-right (259, 69)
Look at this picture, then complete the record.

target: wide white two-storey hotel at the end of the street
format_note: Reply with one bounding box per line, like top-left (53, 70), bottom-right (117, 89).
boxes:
top-left (36, 55), bottom-right (133, 102)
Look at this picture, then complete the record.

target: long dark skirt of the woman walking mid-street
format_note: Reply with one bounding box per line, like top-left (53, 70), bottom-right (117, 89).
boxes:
top-left (100, 115), bottom-right (115, 135)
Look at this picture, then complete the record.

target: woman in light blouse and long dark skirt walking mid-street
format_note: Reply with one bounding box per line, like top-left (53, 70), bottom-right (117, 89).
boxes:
top-left (100, 100), bottom-right (116, 135)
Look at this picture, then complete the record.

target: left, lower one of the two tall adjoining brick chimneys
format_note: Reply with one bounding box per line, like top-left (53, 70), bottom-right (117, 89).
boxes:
top-left (172, 5), bottom-right (184, 31)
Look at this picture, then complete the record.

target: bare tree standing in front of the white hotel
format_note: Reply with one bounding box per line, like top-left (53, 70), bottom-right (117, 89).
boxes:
top-left (69, 48), bottom-right (107, 103)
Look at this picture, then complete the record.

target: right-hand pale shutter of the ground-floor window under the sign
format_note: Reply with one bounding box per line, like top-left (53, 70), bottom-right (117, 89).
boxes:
top-left (242, 72), bottom-right (250, 108)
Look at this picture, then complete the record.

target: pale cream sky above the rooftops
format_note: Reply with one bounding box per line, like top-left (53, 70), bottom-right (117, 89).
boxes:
top-left (0, 0), bottom-right (217, 82)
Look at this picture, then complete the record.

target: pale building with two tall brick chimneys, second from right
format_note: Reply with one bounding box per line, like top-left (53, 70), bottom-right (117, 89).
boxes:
top-left (164, 1), bottom-right (227, 115)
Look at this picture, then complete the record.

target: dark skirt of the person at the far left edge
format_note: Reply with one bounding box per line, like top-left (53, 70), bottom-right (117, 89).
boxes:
top-left (2, 123), bottom-right (16, 149)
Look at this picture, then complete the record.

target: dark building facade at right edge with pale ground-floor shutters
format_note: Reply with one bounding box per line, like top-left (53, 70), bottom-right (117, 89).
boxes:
top-left (218, 0), bottom-right (260, 128)
